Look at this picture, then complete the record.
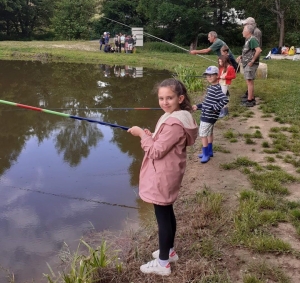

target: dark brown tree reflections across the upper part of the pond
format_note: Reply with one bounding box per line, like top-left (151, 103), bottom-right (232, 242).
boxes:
top-left (0, 61), bottom-right (168, 180)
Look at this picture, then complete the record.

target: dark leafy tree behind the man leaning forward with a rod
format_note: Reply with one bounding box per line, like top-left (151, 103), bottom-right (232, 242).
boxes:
top-left (138, 0), bottom-right (238, 49)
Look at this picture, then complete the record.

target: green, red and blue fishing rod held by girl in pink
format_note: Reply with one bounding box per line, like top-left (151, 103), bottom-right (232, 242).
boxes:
top-left (0, 100), bottom-right (129, 131)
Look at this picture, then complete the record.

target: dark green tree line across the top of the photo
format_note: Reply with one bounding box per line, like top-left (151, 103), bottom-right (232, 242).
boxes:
top-left (0, 0), bottom-right (300, 48)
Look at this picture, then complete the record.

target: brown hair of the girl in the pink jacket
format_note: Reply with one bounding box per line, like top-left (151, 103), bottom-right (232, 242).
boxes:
top-left (154, 78), bottom-right (192, 112)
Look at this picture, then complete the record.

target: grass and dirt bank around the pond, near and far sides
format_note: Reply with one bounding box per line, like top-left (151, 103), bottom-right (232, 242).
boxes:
top-left (0, 42), bottom-right (300, 283)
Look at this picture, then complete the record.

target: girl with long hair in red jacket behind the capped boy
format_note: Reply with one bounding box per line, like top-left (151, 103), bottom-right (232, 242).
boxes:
top-left (218, 55), bottom-right (236, 118)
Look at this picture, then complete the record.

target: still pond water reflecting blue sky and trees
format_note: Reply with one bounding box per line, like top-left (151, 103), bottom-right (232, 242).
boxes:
top-left (0, 61), bottom-right (171, 283)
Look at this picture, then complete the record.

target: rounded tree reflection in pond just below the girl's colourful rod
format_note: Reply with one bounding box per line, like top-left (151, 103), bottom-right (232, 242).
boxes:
top-left (55, 121), bottom-right (103, 166)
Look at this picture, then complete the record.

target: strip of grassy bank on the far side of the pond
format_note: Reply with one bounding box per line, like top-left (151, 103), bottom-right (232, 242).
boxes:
top-left (0, 41), bottom-right (213, 72)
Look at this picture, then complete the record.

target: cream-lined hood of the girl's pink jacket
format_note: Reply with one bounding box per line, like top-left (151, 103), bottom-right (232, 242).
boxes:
top-left (152, 110), bottom-right (198, 145)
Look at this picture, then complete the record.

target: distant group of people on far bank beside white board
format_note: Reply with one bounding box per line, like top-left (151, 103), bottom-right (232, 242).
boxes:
top-left (99, 32), bottom-right (136, 53)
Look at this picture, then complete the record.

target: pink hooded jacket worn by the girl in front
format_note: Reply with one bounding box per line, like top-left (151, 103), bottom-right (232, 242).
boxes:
top-left (139, 110), bottom-right (198, 205)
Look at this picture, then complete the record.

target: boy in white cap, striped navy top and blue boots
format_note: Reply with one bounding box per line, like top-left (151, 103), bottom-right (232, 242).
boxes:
top-left (193, 66), bottom-right (229, 163)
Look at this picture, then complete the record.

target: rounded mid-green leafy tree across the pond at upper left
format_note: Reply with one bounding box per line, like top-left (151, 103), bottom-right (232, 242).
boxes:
top-left (52, 0), bottom-right (97, 40)
